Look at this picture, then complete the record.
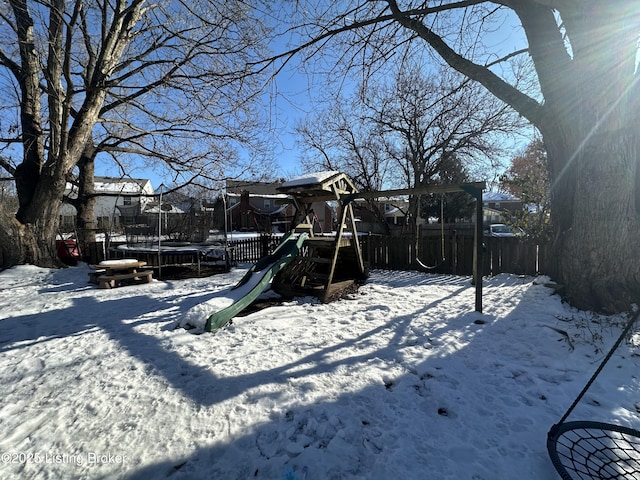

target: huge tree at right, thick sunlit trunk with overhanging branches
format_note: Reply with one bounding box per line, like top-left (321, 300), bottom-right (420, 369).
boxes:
top-left (274, 0), bottom-right (640, 312)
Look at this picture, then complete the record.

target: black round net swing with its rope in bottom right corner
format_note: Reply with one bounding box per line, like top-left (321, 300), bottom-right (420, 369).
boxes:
top-left (547, 309), bottom-right (640, 480)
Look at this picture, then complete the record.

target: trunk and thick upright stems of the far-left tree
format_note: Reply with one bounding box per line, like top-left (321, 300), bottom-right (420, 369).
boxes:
top-left (0, 0), bottom-right (146, 267)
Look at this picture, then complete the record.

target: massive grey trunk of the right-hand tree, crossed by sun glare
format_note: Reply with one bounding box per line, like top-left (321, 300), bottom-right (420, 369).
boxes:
top-left (540, 2), bottom-right (640, 312)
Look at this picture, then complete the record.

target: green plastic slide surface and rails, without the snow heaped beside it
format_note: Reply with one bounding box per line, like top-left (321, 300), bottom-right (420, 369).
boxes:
top-left (204, 233), bottom-right (309, 332)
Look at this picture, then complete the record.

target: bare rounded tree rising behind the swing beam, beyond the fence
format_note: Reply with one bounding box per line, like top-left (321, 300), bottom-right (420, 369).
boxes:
top-left (363, 65), bottom-right (521, 218)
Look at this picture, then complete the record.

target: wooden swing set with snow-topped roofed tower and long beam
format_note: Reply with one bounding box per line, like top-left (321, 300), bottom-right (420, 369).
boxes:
top-left (272, 171), bottom-right (486, 312)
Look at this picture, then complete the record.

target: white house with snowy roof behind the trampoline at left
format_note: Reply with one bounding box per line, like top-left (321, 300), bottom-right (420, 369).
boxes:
top-left (60, 176), bottom-right (155, 230)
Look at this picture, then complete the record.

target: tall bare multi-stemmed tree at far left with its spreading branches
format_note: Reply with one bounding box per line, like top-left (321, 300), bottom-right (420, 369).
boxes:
top-left (0, 0), bottom-right (266, 266)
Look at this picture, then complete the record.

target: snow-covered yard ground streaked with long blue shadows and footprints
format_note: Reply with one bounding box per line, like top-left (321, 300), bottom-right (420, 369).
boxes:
top-left (0, 265), bottom-right (640, 480)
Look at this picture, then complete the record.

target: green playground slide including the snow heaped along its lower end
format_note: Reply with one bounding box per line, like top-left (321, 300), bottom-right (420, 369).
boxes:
top-left (182, 233), bottom-right (308, 332)
